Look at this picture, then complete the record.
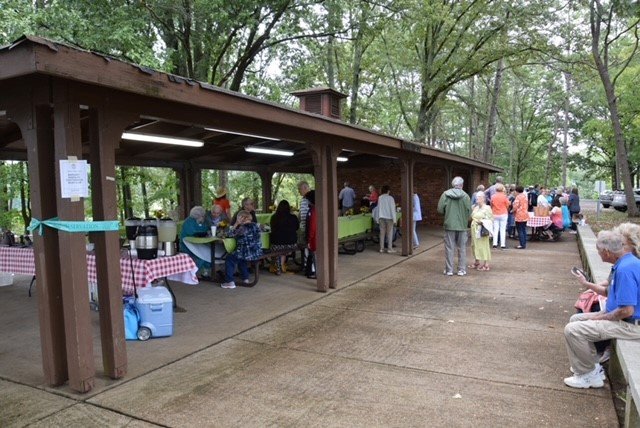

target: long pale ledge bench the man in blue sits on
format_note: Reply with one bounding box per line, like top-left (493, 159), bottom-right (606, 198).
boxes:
top-left (578, 226), bottom-right (640, 428)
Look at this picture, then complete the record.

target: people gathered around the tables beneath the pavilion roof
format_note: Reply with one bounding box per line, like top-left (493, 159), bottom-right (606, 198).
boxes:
top-left (180, 181), bottom-right (422, 288)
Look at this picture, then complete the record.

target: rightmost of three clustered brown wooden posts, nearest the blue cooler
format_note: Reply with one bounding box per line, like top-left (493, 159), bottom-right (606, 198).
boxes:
top-left (89, 107), bottom-right (131, 379)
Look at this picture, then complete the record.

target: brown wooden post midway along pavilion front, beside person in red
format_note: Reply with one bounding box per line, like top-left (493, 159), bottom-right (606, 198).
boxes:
top-left (313, 144), bottom-right (338, 292)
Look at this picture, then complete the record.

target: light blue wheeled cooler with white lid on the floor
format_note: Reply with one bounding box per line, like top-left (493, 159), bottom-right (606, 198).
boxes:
top-left (136, 287), bottom-right (173, 340)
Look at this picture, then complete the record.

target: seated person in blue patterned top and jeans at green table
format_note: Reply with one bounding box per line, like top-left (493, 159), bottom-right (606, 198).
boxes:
top-left (221, 210), bottom-right (262, 288)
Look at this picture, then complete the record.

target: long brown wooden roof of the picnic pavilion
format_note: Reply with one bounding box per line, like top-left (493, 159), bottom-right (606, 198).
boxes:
top-left (0, 36), bottom-right (499, 173)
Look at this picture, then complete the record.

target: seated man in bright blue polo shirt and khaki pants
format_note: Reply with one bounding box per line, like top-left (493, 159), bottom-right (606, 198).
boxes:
top-left (564, 231), bottom-right (640, 388)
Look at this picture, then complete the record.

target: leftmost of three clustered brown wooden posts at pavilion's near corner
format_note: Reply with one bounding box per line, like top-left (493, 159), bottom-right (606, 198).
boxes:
top-left (11, 95), bottom-right (68, 386)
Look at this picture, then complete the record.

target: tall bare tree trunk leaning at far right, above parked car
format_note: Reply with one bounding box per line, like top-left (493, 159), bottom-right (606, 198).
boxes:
top-left (589, 0), bottom-right (638, 217)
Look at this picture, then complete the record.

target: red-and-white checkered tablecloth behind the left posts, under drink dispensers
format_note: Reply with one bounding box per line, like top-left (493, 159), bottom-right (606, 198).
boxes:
top-left (0, 247), bottom-right (197, 296)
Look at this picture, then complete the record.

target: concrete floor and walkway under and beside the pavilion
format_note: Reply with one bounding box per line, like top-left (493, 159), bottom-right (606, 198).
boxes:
top-left (0, 228), bottom-right (618, 427)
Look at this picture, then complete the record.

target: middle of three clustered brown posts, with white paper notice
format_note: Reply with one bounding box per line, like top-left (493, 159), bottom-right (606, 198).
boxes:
top-left (52, 81), bottom-right (95, 392)
